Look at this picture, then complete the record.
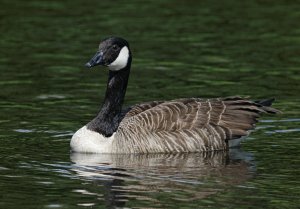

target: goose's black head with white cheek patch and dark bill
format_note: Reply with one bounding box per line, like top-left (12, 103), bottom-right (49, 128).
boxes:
top-left (85, 37), bottom-right (131, 71)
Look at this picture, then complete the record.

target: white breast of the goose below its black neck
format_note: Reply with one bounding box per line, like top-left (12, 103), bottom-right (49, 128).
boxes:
top-left (70, 126), bottom-right (115, 153)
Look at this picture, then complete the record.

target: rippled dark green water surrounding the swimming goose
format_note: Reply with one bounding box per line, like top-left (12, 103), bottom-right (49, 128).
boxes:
top-left (0, 0), bottom-right (300, 209)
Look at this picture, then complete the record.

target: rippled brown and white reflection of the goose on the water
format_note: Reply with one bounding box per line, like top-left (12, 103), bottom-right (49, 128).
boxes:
top-left (71, 149), bottom-right (255, 208)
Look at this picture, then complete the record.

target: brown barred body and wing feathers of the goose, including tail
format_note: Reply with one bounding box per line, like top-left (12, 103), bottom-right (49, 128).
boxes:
top-left (113, 97), bottom-right (279, 153)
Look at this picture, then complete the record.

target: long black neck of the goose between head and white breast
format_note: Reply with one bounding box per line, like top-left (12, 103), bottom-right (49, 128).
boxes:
top-left (87, 58), bottom-right (131, 137)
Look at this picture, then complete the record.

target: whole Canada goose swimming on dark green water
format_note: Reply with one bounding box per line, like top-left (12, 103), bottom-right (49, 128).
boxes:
top-left (70, 37), bottom-right (279, 153)
